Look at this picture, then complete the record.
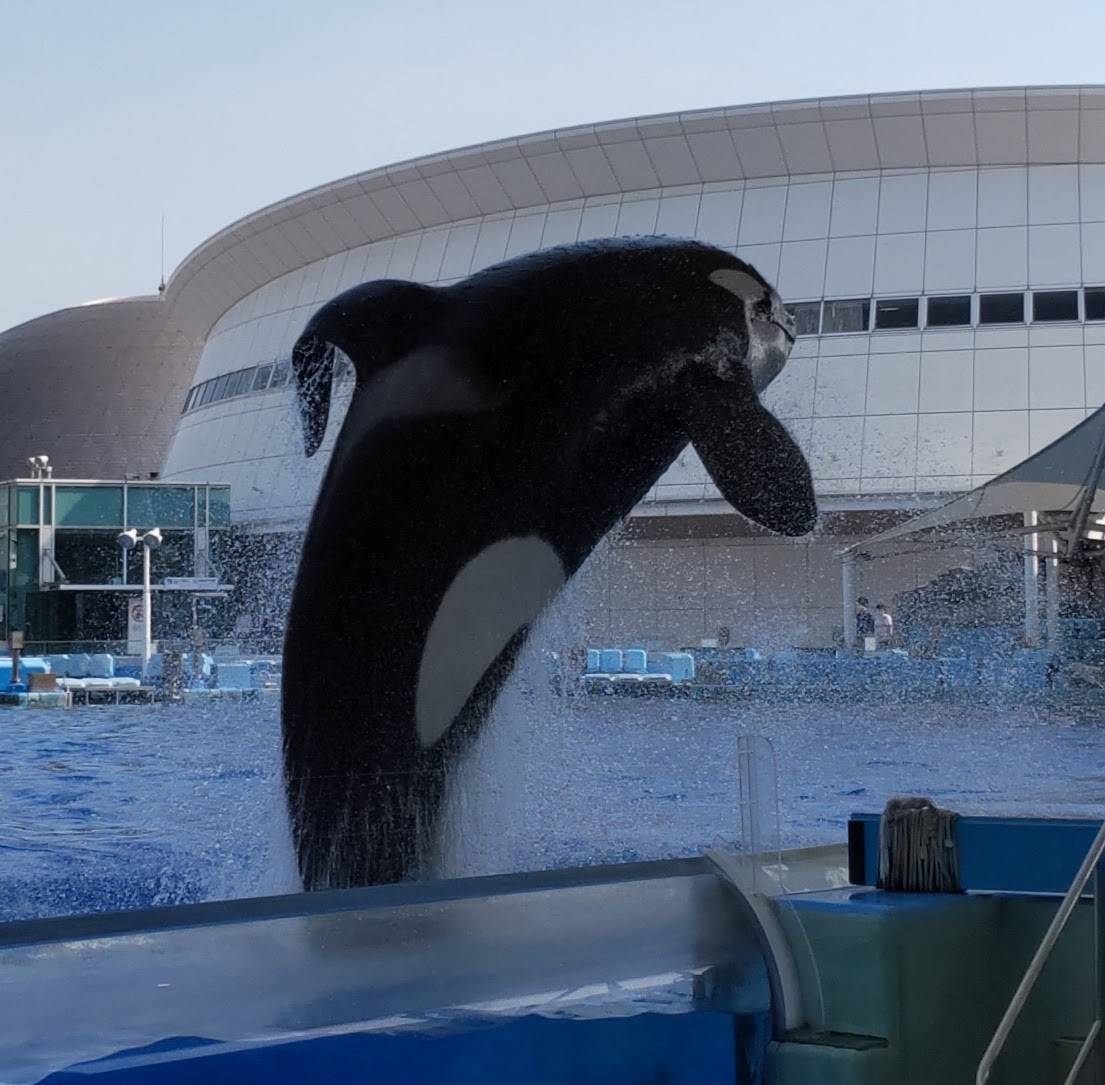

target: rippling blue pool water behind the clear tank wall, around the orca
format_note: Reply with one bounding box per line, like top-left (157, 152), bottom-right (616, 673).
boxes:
top-left (0, 698), bottom-right (1105, 918)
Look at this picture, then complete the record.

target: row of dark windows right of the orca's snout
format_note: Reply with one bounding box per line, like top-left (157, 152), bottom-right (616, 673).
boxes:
top-left (787, 286), bottom-right (1105, 335)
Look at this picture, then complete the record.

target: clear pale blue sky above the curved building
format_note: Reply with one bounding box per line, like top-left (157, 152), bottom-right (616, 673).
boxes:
top-left (0, 0), bottom-right (1105, 328)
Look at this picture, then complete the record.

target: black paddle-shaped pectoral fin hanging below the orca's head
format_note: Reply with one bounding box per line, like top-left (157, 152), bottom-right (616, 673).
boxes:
top-left (687, 402), bottom-right (818, 536)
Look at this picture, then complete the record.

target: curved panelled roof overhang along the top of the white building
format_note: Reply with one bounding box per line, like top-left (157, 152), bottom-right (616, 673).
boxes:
top-left (167, 86), bottom-right (1105, 336)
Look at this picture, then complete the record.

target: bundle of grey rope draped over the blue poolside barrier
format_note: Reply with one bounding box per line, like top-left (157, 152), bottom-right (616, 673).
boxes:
top-left (876, 798), bottom-right (961, 893)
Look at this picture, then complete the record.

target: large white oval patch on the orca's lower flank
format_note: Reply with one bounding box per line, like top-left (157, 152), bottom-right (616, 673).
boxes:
top-left (414, 536), bottom-right (566, 747)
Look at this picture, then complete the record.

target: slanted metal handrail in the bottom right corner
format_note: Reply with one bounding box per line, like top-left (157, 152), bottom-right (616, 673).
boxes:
top-left (975, 822), bottom-right (1105, 1085)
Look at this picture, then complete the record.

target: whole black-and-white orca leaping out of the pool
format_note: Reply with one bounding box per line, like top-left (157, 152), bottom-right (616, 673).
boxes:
top-left (283, 238), bottom-right (817, 889)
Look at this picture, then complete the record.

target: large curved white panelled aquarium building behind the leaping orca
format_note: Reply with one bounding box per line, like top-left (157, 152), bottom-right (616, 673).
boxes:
top-left (80, 86), bottom-right (1105, 646)
